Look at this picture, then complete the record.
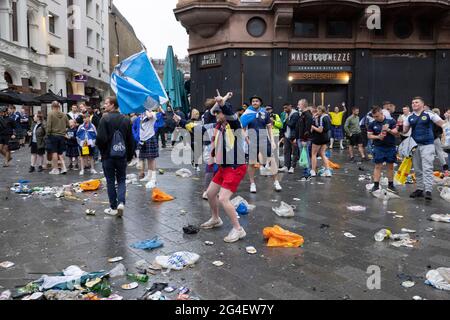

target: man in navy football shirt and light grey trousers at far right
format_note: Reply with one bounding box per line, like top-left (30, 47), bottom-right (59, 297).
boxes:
top-left (403, 97), bottom-right (445, 201)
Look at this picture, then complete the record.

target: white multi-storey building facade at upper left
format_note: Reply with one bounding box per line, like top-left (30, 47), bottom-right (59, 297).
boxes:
top-left (0, 0), bottom-right (110, 107)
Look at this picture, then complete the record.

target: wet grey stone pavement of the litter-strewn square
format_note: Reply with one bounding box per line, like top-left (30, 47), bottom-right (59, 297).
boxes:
top-left (0, 149), bottom-right (450, 300)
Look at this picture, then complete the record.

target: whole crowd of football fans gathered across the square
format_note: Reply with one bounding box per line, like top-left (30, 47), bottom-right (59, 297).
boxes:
top-left (0, 92), bottom-right (450, 243)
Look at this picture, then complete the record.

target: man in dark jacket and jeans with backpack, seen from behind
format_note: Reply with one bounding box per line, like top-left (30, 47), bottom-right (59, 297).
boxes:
top-left (97, 97), bottom-right (134, 217)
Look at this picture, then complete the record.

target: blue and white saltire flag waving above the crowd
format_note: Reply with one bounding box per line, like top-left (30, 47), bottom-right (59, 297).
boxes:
top-left (111, 51), bottom-right (169, 114)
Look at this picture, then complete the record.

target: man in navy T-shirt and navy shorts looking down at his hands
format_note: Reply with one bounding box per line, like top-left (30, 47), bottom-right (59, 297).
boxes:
top-left (368, 106), bottom-right (398, 193)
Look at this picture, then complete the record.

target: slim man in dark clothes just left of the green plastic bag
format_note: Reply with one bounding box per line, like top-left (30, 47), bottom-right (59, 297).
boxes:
top-left (280, 103), bottom-right (300, 174)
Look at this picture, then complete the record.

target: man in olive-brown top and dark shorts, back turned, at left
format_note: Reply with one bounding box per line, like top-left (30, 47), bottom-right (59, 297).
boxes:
top-left (46, 101), bottom-right (69, 175)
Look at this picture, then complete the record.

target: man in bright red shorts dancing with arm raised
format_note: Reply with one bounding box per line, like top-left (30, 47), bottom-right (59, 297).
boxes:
top-left (201, 93), bottom-right (247, 243)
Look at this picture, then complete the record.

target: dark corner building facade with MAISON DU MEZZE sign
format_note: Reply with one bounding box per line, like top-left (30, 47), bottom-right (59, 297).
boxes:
top-left (174, 0), bottom-right (450, 110)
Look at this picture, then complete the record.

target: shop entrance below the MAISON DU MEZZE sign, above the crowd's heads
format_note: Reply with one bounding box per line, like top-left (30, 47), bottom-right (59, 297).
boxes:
top-left (291, 84), bottom-right (348, 107)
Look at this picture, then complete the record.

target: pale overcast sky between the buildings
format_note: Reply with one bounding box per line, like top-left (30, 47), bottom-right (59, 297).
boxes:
top-left (114, 0), bottom-right (188, 58)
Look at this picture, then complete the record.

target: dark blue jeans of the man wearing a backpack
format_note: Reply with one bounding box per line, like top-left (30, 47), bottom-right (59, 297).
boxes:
top-left (103, 158), bottom-right (127, 210)
